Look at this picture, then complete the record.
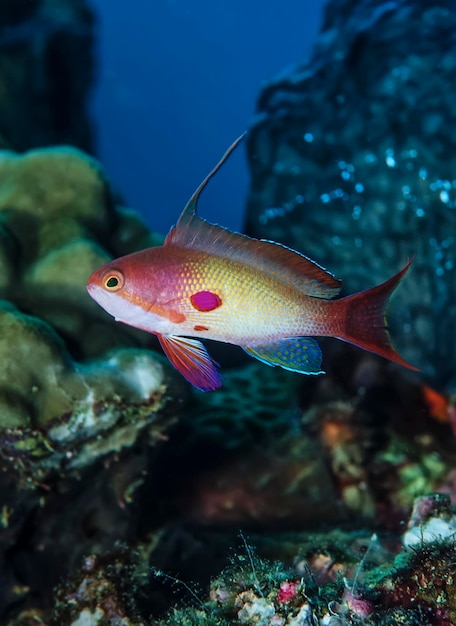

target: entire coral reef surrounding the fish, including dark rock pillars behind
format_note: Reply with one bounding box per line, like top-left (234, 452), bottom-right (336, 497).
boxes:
top-left (0, 0), bottom-right (456, 626)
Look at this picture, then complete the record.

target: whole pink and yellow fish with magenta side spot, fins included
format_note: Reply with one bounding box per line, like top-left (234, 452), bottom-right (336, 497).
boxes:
top-left (87, 137), bottom-right (415, 391)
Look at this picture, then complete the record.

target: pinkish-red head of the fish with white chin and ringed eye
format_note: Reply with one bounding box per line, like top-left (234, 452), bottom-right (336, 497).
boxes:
top-left (87, 249), bottom-right (183, 333)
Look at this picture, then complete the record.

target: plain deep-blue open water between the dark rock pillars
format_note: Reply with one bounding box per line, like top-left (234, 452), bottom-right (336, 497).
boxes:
top-left (92, 0), bottom-right (324, 233)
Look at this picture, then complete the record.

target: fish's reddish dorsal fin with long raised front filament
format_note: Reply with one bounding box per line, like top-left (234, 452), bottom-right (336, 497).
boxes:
top-left (164, 133), bottom-right (340, 298)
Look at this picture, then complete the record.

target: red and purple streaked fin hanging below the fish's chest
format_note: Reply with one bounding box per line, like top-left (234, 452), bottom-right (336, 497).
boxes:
top-left (157, 335), bottom-right (222, 391)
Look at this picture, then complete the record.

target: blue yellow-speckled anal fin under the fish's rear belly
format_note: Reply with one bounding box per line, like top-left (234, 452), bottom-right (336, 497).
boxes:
top-left (243, 337), bottom-right (324, 374)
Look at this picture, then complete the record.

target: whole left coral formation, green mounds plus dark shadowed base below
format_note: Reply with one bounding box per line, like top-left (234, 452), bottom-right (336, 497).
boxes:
top-left (0, 148), bottom-right (188, 619)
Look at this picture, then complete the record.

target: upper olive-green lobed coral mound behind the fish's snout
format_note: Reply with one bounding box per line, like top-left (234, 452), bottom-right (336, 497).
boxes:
top-left (0, 148), bottom-right (162, 357)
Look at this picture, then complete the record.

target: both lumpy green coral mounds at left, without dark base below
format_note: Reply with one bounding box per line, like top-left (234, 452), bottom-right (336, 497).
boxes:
top-left (0, 147), bottom-right (183, 485)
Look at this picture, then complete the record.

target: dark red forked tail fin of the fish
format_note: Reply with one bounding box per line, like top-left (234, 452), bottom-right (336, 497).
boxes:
top-left (334, 259), bottom-right (418, 370)
